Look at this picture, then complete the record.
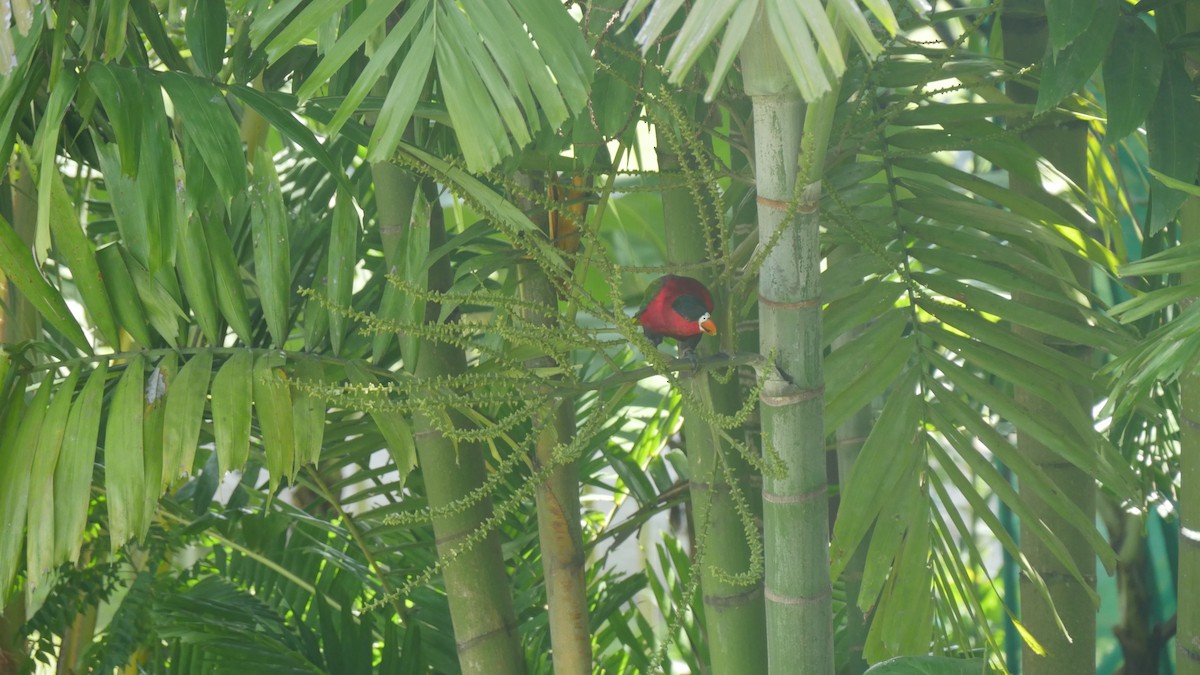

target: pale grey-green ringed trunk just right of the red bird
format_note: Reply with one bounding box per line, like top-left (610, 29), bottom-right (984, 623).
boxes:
top-left (742, 6), bottom-right (836, 675)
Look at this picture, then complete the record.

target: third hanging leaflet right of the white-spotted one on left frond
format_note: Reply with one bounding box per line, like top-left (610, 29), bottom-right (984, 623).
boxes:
top-left (253, 353), bottom-right (296, 494)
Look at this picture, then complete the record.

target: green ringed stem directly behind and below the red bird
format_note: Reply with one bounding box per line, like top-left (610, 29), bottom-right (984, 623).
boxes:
top-left (656, 133), bottom-right (767, 675)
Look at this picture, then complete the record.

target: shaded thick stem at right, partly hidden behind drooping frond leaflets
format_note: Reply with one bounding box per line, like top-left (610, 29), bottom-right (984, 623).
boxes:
top-left (1002, 0), bottom-right (1097, 675)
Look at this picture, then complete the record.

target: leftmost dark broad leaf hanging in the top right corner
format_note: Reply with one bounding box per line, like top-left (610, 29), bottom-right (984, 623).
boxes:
top-left (1034, 0), bottom-right (1120, 114)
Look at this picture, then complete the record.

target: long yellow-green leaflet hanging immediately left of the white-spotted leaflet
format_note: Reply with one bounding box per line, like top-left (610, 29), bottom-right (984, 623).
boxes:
top-left (104, 356), bottom-right (150, 554)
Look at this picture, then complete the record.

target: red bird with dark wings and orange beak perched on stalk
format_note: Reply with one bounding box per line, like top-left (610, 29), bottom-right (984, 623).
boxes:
top-left (634, 274), bottom-right (716, 366)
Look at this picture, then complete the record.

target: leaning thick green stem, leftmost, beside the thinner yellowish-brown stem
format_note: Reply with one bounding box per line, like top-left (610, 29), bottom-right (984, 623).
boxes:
top-left (371, 162), bottom-right (526, 675)
